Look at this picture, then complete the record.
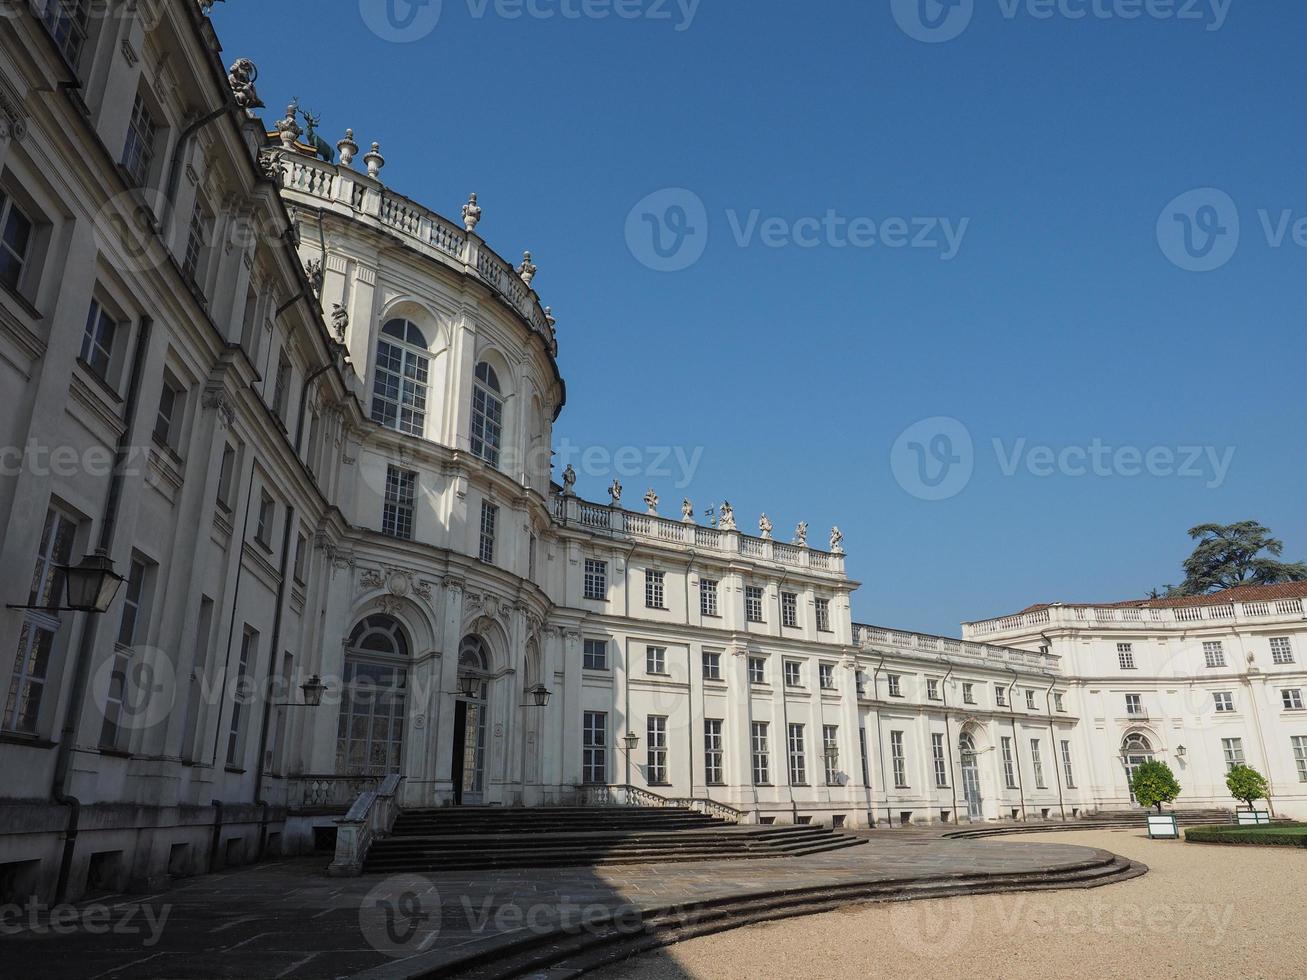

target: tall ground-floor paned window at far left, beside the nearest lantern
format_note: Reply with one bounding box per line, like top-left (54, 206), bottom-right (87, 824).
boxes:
top-left (3, 507), bottom-right (77, 734)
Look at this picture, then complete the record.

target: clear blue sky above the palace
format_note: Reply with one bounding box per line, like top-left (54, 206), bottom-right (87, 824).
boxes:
top-left (213, 0), bottom-right (1307, 634)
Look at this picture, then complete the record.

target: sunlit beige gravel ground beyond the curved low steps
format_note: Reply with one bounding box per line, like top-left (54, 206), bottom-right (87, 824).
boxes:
top-left (593, 830), bottom-right (1307, 980)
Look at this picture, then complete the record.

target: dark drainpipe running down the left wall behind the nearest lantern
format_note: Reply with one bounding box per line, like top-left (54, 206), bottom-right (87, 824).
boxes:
top-left (50, 316), bottom-right (154, 902)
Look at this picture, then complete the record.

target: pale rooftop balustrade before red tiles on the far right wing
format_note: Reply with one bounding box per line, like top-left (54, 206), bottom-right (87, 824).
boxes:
top-left (962, 598), bottom-right (1303, 638)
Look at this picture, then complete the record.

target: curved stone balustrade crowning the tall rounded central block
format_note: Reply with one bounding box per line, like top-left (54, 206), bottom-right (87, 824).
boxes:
top-left (272, 150), bottom-right (558, 354)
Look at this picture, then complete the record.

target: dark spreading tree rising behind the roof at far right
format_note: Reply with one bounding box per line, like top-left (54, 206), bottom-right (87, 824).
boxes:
top-left (1167, 520), bottom-right (1307, 597)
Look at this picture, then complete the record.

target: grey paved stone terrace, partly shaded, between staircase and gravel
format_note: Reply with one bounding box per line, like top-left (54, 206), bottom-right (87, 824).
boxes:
top-left (0, 831), bottom-right (1118, 980)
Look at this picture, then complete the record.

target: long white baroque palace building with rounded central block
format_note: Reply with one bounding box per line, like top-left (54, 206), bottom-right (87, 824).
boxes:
top-left (0, 0), bottom-right (1307, 898)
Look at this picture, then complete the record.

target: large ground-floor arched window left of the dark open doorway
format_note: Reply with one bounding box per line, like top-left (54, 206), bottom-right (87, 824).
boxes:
top-left (336, 615), bottom-right (409, 776)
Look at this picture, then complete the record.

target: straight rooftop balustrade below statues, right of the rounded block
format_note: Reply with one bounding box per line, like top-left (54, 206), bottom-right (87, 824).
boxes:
top-left (553, 494), bottom-right (844, 576)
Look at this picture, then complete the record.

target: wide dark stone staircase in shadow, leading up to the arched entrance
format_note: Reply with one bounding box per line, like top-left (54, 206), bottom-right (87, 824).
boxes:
top-left (363, 806), bottom-right (868, 874)
